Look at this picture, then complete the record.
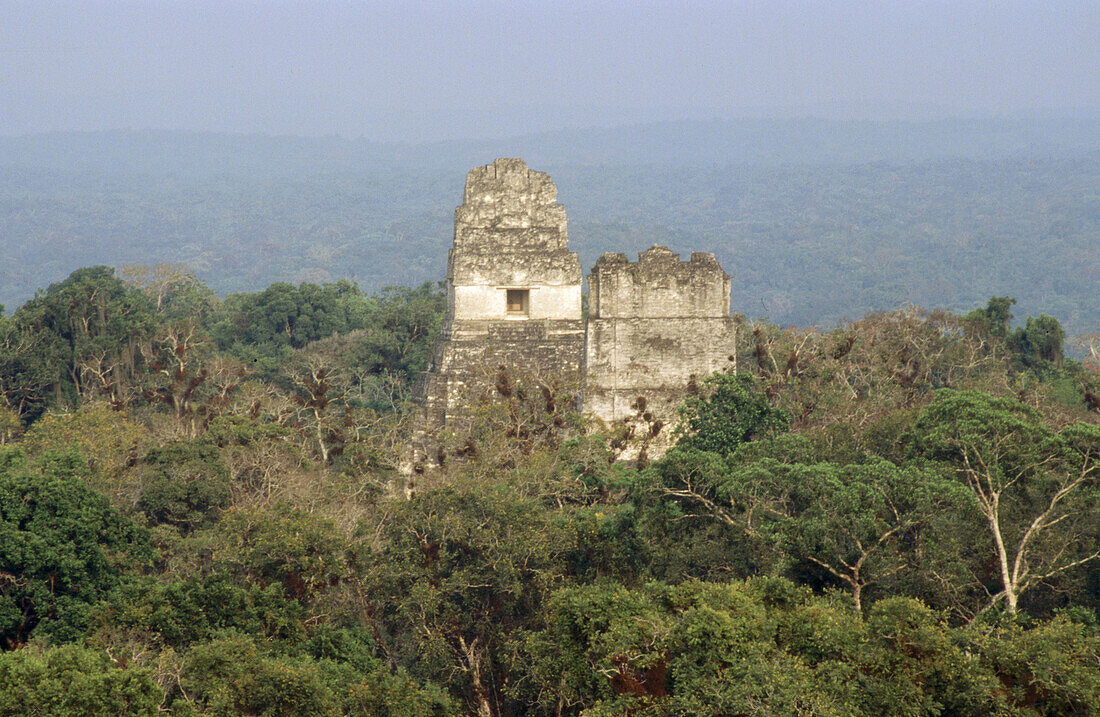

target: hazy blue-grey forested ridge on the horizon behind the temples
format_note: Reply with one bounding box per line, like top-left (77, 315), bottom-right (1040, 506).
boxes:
top-left (0, 120), bottom-right (1100, 334)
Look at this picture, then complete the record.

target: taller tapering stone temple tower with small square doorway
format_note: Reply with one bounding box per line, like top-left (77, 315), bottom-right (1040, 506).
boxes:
top-left (422, 159), bottom-right (584, 427)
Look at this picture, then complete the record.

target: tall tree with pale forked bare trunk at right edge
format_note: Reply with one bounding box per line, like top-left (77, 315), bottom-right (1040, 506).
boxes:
top-left (915, 389), bottom-right (1100, 613)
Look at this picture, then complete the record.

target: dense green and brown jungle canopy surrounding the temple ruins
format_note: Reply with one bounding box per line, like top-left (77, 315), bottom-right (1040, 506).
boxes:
top-left (0, 265), bottom-right (1100, 717)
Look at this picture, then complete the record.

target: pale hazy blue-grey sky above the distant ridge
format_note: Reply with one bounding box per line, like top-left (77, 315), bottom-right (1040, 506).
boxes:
top-left (0, 0), bottom-right (1100, 141)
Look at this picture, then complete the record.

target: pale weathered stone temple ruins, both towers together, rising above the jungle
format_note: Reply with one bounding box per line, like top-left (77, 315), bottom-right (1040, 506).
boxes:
top-left (420, 159), bottom-right (737, 457)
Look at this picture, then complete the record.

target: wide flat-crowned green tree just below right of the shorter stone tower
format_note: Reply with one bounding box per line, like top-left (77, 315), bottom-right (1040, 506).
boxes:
top-left (649, 450), bottom-right (961, 609)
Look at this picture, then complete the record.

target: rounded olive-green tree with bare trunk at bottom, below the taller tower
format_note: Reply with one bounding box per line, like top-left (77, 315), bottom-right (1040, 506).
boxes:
top-left (364, 487), bottom-right (570, 717)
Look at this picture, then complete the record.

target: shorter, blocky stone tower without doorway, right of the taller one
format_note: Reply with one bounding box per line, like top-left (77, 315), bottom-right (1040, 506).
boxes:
top-left (584, 246), bottom-right (737, 457)
